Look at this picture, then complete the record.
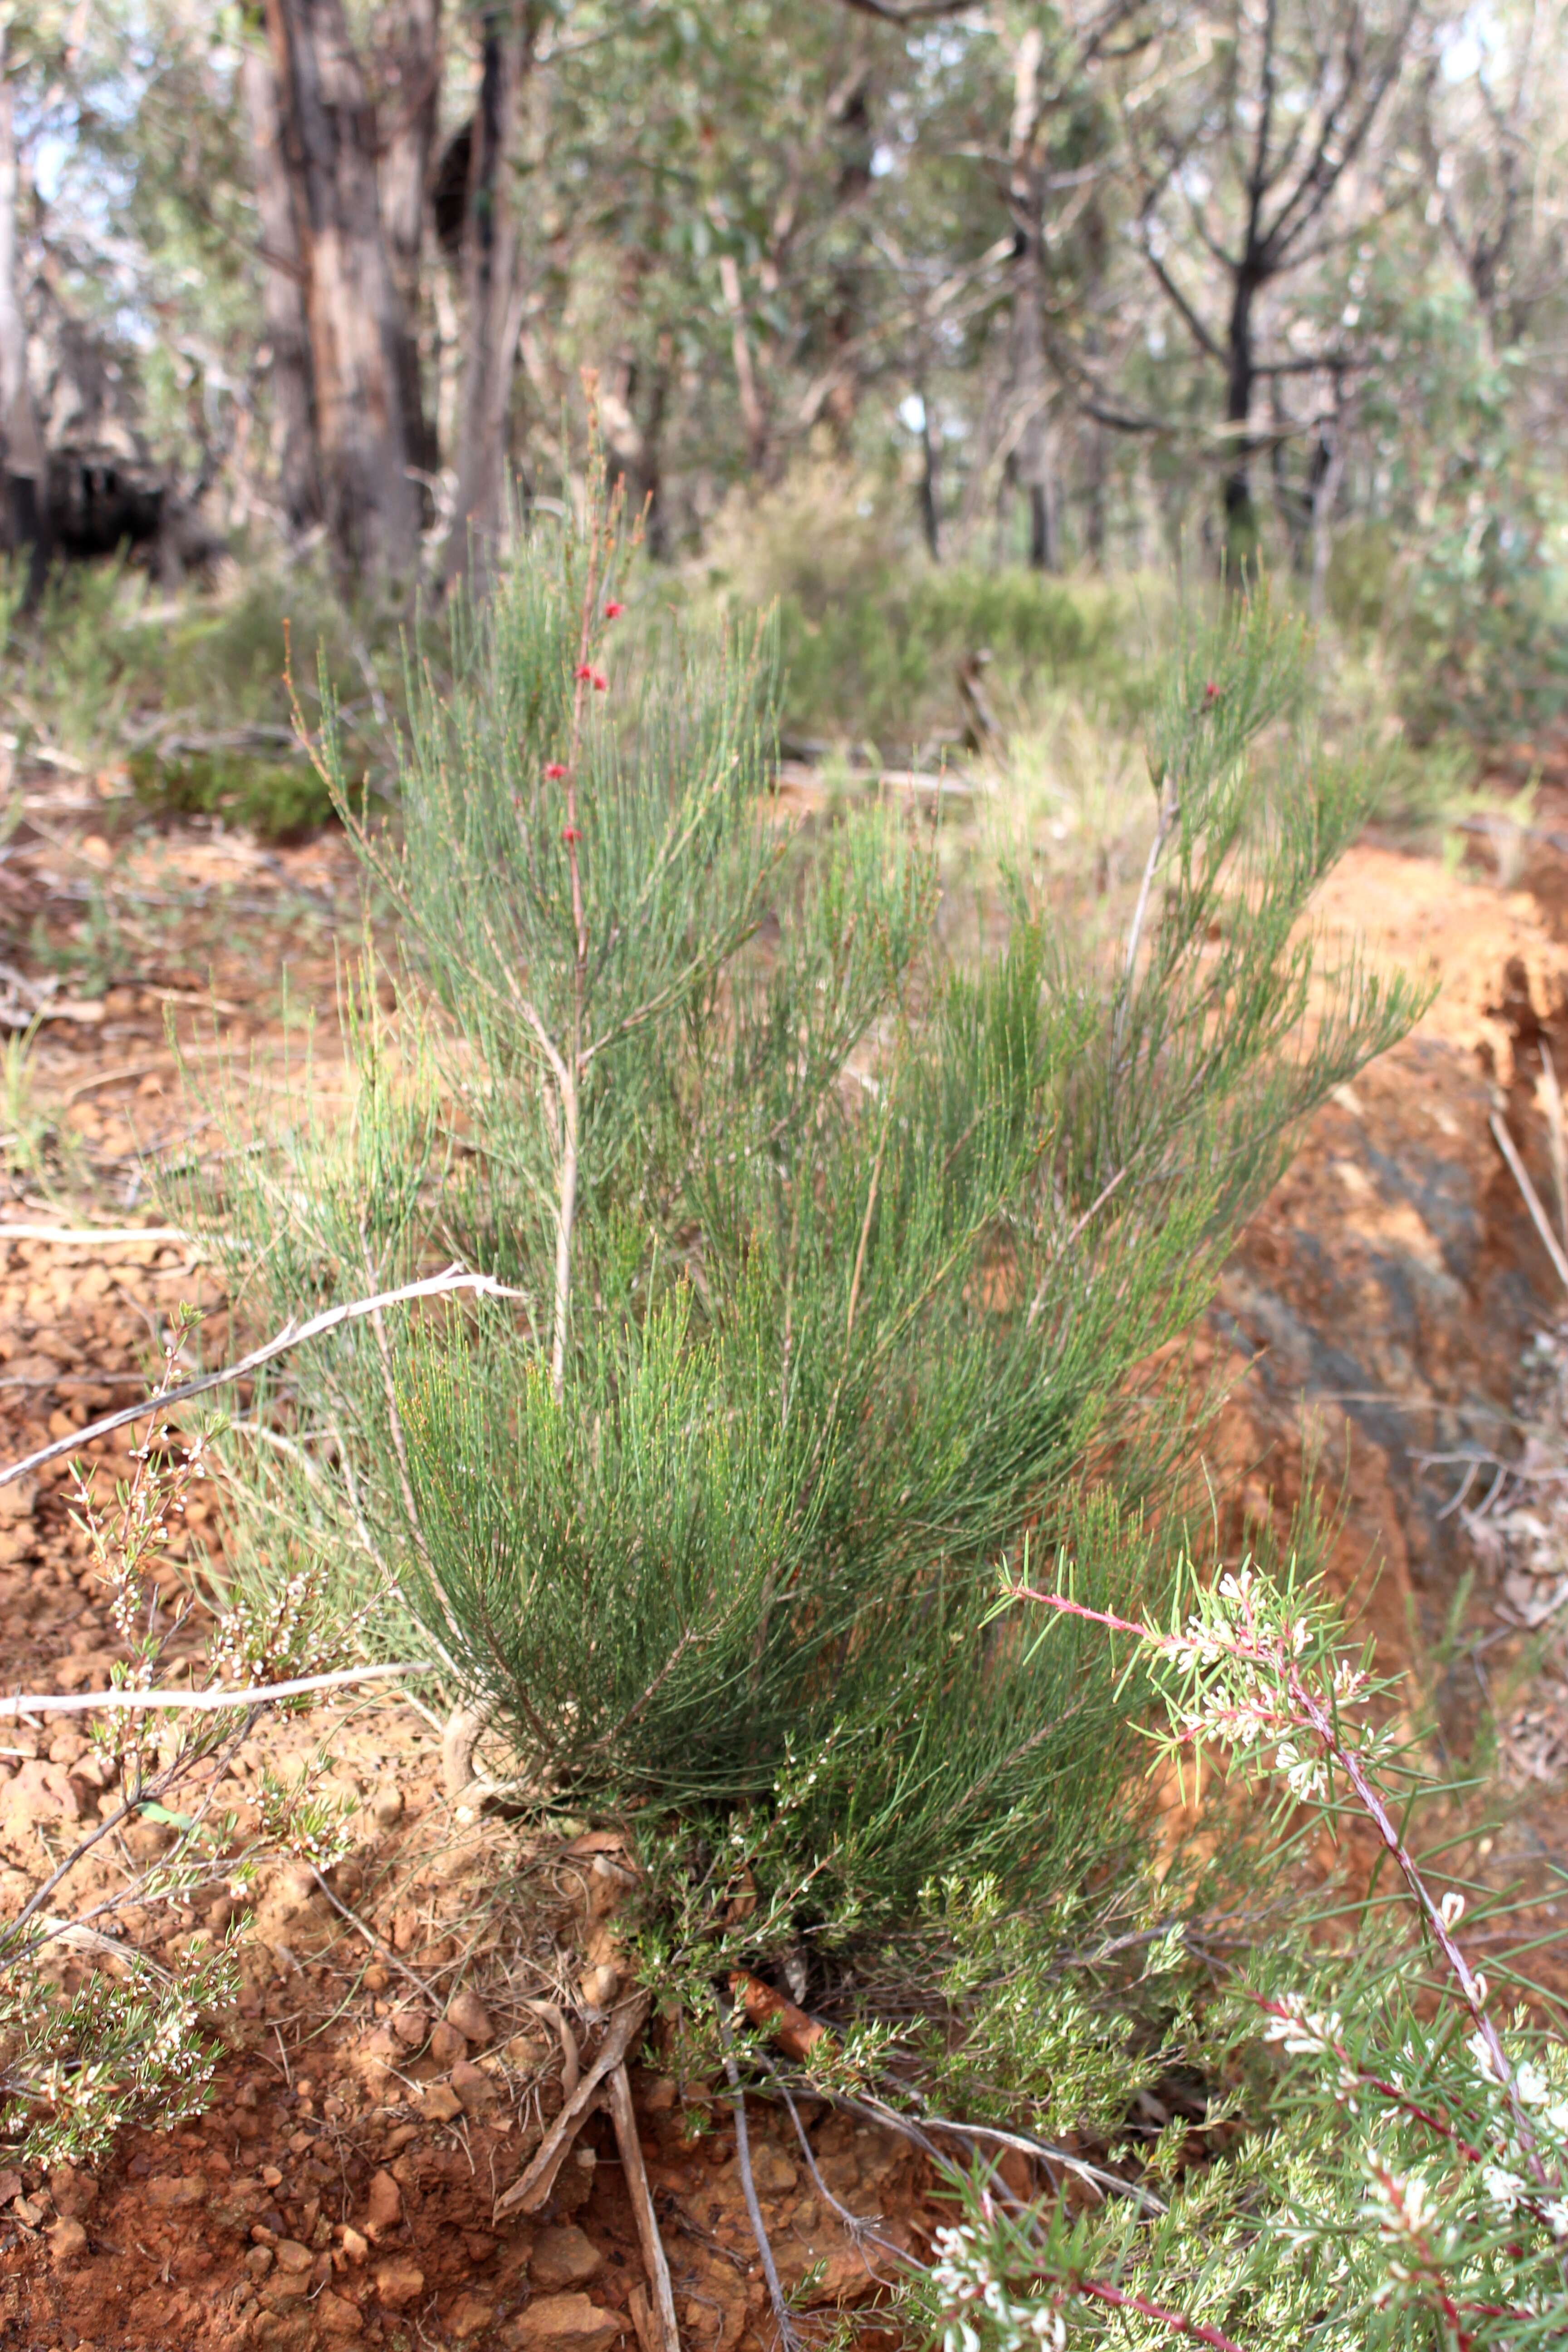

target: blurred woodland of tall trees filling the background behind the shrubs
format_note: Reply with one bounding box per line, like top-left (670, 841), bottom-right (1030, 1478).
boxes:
top-left (0, 0), bottom-right (1568, 736)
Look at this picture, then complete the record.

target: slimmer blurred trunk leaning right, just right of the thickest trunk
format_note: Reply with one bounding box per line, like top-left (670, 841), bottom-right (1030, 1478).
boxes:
top-left (442, 0), bottom-right (536, 583)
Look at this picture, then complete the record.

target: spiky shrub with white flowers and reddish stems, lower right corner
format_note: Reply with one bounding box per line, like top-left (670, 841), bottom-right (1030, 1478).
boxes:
top-left (910, 1555), bottom-right (1568, 2352)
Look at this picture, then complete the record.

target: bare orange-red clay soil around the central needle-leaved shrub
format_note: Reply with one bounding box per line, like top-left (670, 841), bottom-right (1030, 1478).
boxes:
top-left (0, 781), bottom-right (1568, 2352)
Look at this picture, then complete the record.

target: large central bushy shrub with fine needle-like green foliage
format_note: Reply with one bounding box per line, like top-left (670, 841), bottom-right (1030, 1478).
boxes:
top-left (206, 487), bottom-right (1413, 1924)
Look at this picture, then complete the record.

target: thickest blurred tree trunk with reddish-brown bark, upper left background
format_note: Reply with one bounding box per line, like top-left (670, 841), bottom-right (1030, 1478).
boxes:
top-left (265, 0), bottom-right (418, 583)
